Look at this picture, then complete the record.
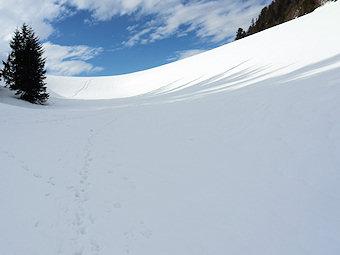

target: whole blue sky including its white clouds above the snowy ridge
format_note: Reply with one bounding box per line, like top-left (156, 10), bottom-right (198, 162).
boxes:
top-left (0, 0), bottom-right (270, 76)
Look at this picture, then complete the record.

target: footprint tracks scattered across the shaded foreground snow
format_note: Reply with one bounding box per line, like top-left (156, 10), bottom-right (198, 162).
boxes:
top-left (2, 124), bottom-right (152, 255)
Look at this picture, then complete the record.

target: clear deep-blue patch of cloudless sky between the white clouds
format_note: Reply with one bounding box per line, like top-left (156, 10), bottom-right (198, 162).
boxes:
top-left (49, 11), bottom-right (218, 75)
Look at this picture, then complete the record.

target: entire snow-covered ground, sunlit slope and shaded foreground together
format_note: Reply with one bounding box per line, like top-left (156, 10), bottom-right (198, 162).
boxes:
top-left (0, 1), bottom-right (340, 255)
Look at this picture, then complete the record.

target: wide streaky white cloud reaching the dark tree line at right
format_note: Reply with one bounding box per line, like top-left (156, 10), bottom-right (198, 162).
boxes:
top-left (64, 0), bottom-right (270, 47)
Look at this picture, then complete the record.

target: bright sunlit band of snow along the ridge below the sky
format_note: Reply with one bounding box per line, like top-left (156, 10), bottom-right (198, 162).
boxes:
top-left (47, 1), bottom-right (340, 99)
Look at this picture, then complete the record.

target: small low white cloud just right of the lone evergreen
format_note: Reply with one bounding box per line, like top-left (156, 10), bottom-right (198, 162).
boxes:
top-left (43, 42), bottom-right (103, 75)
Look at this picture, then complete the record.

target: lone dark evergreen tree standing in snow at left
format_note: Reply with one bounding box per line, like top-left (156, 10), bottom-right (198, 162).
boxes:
top-left (1, 24), bottom-right (49, 104)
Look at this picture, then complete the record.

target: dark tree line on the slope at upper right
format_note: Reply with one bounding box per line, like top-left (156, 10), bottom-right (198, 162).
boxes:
top-left (235, 0), bottom-right (336, 40)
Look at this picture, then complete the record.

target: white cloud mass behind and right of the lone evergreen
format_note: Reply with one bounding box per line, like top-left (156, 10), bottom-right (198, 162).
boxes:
top-left (0, 0), bottom-right (102, 75)
